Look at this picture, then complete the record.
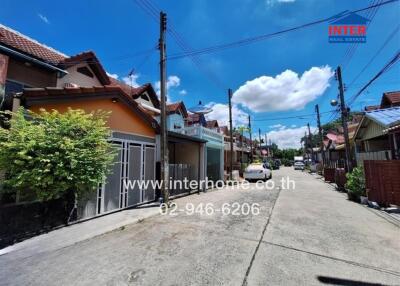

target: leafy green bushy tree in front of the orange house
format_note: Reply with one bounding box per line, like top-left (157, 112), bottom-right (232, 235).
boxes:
top-left (0, 108), bottom-right (115, 201)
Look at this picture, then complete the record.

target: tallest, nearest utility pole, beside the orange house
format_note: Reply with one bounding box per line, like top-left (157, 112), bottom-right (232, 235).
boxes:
top-left (159, 12), bottom-right (169, 204)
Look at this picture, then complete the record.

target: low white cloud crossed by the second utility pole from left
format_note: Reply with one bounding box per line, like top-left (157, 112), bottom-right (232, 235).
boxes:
top-left (205, 102), bottom-right (248, 127)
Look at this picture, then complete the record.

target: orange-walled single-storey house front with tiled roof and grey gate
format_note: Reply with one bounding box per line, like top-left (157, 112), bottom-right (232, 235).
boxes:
top-left (20, 86), bottom-right (159, 219)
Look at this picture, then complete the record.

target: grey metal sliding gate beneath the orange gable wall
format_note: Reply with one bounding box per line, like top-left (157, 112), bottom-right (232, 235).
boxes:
top-left (79, 139), bottom-right (156, 219)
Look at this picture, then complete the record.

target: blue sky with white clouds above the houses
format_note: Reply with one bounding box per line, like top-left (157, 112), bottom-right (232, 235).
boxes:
top-left (0, 0), bottom-right (400, 147)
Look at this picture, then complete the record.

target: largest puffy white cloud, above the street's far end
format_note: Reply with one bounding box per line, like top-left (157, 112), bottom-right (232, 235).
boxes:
top-left (232, 66), bottom-right (333, 112)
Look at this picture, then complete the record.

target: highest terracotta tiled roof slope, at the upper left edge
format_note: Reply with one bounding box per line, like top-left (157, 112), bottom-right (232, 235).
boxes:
top-left (0, 24), bottom-right (68, 65)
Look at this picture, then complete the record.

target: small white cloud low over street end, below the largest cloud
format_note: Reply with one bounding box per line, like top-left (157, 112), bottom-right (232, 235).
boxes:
top-left (267, 125), bottom-right (317, 149)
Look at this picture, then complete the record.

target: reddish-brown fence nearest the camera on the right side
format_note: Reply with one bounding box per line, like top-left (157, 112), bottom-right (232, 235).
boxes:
top-left (364, 160), bottom-right (400, 206)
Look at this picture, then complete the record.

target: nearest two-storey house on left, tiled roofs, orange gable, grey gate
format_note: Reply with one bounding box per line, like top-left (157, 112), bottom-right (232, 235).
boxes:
top-left (0, 26), bottom-right (159, 219)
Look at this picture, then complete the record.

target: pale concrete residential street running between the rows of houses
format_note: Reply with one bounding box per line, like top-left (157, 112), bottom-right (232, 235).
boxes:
top-left (0, 167), bottom-right (400, 285)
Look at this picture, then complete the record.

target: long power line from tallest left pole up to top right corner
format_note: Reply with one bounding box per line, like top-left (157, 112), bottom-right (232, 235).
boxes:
top-left (167, 0), bottom-right (399, 60)
